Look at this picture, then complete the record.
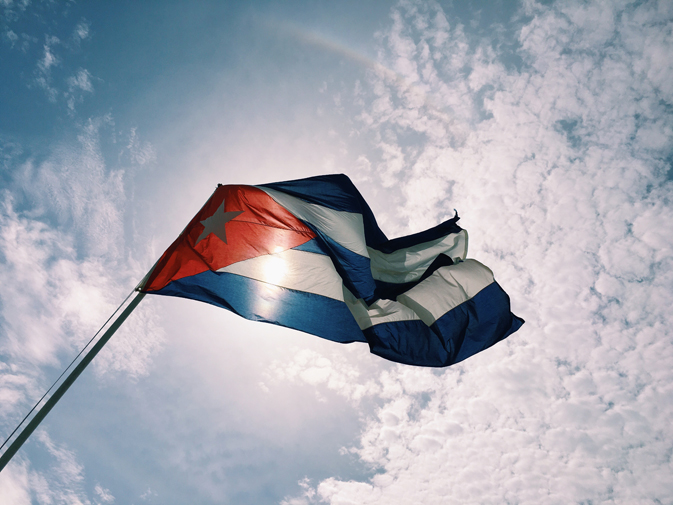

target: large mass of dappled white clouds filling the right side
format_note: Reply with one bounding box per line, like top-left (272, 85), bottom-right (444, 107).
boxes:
top-left (276, 1), bottom-right (673, 504)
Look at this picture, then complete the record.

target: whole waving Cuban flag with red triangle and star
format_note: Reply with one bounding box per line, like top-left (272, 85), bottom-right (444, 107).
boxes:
top-left (140, 175), bottom-right (523, 367)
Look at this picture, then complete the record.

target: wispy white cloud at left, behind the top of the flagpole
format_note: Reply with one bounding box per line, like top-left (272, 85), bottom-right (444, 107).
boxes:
top-left (0, 118), bottom-right (161, 376)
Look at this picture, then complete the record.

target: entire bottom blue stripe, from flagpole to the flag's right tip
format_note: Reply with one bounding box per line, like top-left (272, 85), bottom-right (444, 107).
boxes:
top-left (153, 271), bottom-right (523, 367)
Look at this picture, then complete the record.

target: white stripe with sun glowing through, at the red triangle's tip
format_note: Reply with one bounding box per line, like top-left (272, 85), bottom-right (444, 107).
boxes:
top-left (218, 249), bottom-right (344, 301)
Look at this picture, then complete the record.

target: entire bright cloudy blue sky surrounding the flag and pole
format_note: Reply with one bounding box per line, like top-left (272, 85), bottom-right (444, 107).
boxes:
top-left (0, 0), bottom-right (673, 505)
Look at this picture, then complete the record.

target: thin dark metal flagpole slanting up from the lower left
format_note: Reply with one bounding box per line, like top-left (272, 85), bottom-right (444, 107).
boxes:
top-left (0, 290), bottom-right (146, 472)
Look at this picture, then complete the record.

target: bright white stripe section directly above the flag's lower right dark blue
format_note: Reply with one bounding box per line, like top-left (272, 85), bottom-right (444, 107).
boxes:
top-left (397, 260), bottom-right (494, 326)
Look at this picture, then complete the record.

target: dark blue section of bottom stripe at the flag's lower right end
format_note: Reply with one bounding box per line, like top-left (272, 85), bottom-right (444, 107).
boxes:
top-left (364, 282), bottom-right (524, 367)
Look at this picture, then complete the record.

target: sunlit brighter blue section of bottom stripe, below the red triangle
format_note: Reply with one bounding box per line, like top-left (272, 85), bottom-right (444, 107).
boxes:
top-left (152, 270), bottom-right (366, 343)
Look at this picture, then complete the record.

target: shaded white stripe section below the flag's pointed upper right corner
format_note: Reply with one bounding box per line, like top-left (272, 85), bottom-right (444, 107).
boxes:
top-left (369, 230), bottom-right (467, 283)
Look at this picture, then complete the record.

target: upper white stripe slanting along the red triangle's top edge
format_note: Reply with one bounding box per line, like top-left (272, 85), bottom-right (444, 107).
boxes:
top-left (256, 186), bottom-right (369, 257)
